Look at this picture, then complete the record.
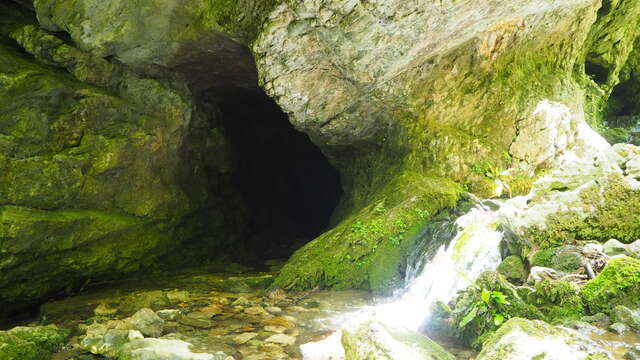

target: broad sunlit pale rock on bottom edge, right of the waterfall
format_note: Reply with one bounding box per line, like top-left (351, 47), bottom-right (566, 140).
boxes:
top-left (477, 318), bottom-right (612, 360)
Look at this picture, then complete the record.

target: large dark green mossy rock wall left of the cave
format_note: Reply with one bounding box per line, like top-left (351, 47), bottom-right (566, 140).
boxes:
top-left (0, 4), bottom-right (240, 311)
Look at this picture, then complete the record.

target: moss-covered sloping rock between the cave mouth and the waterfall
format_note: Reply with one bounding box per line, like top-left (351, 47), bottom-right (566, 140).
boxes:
top-left (275, 174), bottom-right (461, 291)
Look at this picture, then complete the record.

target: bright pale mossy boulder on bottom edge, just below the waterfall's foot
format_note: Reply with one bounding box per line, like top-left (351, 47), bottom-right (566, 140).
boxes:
top-left (341, 321), bottom-right (455, 360)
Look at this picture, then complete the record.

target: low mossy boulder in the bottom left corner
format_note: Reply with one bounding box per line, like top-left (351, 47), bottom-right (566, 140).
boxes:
top-left (0, 326), bottom-right (71, 360)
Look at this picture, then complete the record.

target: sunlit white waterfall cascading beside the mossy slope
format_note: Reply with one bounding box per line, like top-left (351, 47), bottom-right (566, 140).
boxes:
top-left (370, 205), bottom-right (503, 331)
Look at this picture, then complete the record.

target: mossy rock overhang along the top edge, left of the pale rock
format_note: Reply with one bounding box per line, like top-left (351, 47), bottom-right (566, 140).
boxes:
top-left (34, 0), bottom-right (281, 65)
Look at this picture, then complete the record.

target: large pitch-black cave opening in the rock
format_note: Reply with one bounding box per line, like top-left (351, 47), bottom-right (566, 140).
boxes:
top-left (210, 88), bottom-right (342, 262)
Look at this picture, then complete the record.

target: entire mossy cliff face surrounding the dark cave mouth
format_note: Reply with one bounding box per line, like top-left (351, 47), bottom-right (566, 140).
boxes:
top-left (0, 0), bottom-right (640, 306)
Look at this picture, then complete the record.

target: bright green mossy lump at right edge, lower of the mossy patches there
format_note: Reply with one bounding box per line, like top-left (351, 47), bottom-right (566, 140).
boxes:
top-left (580, 257), bottom-right (640, 314)
